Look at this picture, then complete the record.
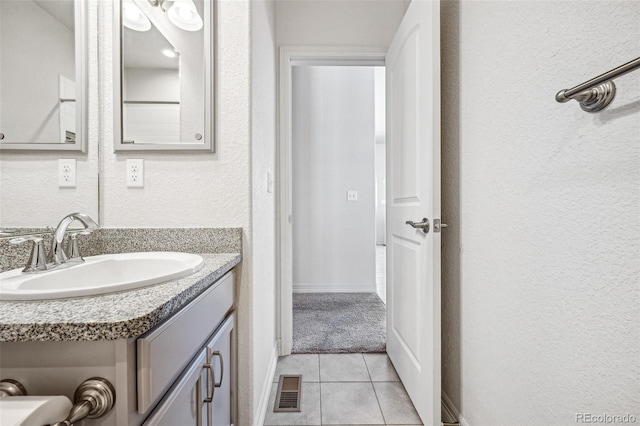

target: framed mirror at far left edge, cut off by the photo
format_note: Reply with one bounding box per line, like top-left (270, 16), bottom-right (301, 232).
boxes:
top-left (0, 0), bottom-right (88, 152)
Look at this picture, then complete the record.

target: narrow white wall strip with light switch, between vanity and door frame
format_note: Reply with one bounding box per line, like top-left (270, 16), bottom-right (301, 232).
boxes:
top-left (249, 0), bottom-right (277, 425)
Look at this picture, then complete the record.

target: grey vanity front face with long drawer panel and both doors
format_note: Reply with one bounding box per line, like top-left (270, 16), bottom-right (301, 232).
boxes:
top-left (137, 274), bottom-right (235, 426)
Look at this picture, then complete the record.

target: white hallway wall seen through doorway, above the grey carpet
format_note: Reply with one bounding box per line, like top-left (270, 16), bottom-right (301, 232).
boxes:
top-left (291, 66), bottom-right (375, 291)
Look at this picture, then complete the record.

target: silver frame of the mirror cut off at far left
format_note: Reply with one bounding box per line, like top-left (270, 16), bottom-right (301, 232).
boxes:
top-left (0, 0), bottom-right (89, 153)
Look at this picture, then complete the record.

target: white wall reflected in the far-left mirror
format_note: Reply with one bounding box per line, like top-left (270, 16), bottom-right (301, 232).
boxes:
top-left (0, 0), bottom-right (75, 143)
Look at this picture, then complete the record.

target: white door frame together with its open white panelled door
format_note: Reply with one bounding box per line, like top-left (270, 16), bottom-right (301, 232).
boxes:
top-left (277, 2), bottom-right (441, 416)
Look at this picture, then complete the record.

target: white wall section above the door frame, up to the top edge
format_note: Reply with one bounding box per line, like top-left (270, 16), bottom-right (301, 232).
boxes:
top-left (276, 0), bottom-right (409, 46)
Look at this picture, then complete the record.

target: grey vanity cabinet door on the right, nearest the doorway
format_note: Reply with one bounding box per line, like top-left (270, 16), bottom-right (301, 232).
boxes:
top-left (204, 315), bottom-right (235, 426)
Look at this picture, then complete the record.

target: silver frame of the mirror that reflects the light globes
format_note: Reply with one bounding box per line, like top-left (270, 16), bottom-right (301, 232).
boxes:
top-left (113, 0), bottom-right (216, 152)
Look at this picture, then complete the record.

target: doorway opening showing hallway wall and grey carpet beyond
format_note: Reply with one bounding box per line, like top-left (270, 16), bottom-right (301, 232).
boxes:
top-left (292, 64), bottom-right (386, 353)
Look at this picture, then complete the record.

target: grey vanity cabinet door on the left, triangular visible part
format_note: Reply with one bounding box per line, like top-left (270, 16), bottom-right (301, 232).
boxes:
top-left (143, 349), bottom-right (207, 426)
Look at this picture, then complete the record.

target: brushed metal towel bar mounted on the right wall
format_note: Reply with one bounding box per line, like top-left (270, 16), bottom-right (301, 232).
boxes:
top-left (556, 58), bottom-right (640, 112)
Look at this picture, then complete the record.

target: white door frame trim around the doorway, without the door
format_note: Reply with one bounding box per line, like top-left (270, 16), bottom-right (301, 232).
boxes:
top-left (276, 46), bottom-right (387, 356)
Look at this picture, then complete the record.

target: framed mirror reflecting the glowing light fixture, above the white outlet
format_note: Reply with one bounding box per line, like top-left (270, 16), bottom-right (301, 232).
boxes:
top-left (114, 0), bottom-right (215, 152)
